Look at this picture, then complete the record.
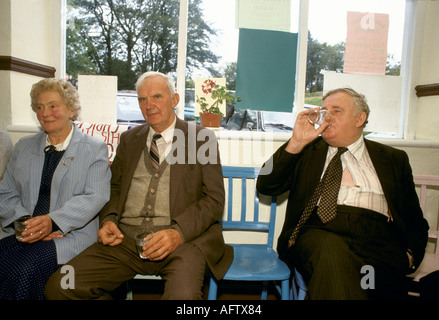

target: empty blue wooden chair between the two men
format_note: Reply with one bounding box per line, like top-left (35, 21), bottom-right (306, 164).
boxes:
top-left (208, 166), bottom-right (290, 300)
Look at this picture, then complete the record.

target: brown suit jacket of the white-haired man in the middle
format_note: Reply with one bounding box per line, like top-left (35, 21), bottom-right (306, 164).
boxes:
top-left (100, 119), bottom-right (233, 279)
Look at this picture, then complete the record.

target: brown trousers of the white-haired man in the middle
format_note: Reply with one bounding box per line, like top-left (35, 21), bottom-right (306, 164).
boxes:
top-left (45, 236), bottom-right (206, 300)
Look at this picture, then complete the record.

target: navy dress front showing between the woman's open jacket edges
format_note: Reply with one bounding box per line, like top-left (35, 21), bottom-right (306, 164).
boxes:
top-left (32, 146), bottom-right (64, 216)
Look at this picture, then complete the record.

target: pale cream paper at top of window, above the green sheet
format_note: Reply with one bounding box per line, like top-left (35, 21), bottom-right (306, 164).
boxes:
top-left (236, 0), bottom-right (291, 32)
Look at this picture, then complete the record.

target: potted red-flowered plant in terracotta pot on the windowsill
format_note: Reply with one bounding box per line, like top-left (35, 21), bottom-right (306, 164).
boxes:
top-left (196, 79), bottom-right (235, 127)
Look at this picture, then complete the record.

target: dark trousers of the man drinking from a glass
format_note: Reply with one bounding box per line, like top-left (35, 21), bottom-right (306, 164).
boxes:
top-left (287, 206), bottom-right (409, 300)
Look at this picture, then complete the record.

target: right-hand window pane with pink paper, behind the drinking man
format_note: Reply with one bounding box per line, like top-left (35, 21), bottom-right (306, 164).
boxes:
top-left (305, 0), bottom-right (405, 135)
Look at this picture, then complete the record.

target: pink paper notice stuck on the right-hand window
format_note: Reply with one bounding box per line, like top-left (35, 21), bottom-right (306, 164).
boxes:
top-left (343, 12), bottom-right (389, 75)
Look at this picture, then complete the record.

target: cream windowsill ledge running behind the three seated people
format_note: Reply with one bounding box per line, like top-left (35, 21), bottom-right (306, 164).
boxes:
top-left (6, 124), bottom-right (439, 148)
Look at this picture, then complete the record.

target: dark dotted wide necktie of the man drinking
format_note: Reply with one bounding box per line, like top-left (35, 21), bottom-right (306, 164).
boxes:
top-left (288, 147), bottom-right (348, 248)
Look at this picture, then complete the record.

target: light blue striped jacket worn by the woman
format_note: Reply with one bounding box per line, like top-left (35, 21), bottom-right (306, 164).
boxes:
top-left (0, 126), bottom-right (111, 264)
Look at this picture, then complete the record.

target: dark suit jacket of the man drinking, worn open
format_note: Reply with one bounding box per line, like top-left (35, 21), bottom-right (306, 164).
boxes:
top-left (257, 137), bottom-right (428, 266)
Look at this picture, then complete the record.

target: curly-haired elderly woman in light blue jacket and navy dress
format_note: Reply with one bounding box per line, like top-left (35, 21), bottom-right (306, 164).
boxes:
top-left (0, 79), bottom-right (111, 300)
